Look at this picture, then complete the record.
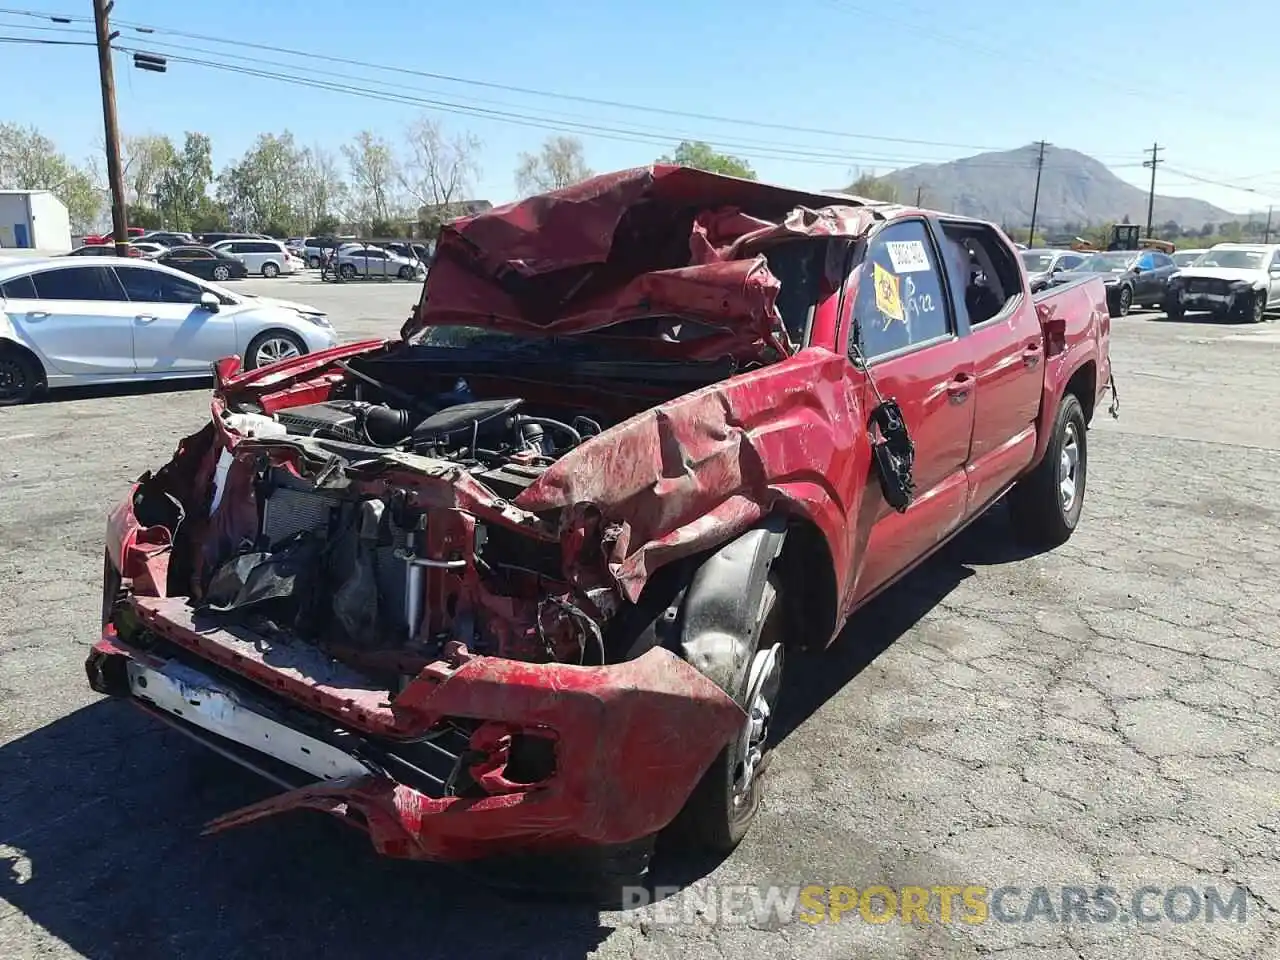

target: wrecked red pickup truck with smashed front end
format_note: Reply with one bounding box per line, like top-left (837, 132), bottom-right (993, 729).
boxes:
top-left (87, 166), bottom-right (1111, 896)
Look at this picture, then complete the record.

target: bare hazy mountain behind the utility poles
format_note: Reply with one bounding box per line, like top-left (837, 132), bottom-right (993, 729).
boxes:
top-left (849, 143), bottom-right (1242, 228)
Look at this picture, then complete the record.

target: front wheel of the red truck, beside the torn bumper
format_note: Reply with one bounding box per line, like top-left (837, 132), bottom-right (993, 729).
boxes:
top-left (672, 573), bottom-right (785, 854)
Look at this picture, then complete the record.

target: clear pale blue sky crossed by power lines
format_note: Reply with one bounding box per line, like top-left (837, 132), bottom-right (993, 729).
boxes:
top-left (0, 0), bottom-right (1280, 210)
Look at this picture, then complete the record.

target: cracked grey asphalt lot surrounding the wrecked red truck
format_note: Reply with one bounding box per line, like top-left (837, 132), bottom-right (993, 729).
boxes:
top-left (0, 278), bottom-right (1280, 960)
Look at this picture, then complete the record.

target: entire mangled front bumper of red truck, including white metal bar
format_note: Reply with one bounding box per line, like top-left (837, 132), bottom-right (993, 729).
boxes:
top-left (86, 598), bottom-right (745, 861)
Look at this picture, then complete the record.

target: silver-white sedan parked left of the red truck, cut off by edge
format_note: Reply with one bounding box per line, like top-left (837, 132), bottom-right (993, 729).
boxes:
top-left (0, 256), bottom-right (338, 406)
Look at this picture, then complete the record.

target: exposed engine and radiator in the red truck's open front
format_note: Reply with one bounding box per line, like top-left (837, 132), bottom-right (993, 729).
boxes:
top-left (202, 384), bottom-right (627, 689)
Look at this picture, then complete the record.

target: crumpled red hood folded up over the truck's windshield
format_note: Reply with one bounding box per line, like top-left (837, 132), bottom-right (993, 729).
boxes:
top-left (401, 165), bottom-right (882, 356)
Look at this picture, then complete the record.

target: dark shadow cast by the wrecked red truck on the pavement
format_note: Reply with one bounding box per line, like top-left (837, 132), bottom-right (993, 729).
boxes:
top-left (0, 511), bottom-right (1039, 960)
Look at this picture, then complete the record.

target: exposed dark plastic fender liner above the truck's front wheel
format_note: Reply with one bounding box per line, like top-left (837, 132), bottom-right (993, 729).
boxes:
top-left (680, 515), bottom-right (787, 699)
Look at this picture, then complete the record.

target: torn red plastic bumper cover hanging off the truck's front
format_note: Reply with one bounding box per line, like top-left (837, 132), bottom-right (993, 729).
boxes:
top-left (176, 648), bottom-right (745, 860)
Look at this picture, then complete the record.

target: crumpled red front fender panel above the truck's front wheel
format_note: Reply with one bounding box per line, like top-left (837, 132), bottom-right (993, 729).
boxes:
top-left (515, 349), bottom-right (869, 600)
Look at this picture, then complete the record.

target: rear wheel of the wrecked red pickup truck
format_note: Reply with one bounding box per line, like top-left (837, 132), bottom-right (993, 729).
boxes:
top-left (1009, 393), bottom-right (1089, 549)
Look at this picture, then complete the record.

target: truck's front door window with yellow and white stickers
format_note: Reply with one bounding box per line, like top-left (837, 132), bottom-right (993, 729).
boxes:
top-left (854, 220), bottom-right (951, 361)
